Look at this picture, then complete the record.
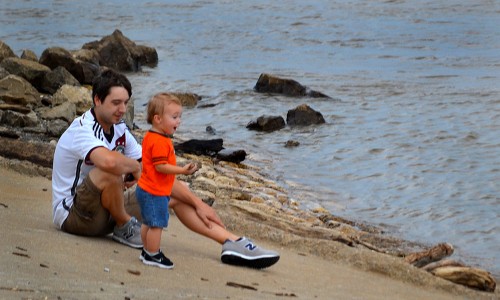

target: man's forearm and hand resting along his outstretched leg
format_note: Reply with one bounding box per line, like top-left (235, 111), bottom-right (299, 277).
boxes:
top-left (171, 179), bottom-right (225, 228)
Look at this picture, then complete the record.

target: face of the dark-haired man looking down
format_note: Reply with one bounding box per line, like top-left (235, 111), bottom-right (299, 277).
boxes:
top-left (94, 86), bottom-right (129, 130)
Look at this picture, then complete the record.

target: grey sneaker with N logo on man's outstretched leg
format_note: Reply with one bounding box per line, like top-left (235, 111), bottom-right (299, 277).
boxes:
top-left (220, 237), bottom-right (280, 269)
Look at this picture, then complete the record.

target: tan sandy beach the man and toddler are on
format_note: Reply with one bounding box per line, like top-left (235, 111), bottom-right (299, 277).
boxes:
top-left (0, 165), bottom-right (499, 299)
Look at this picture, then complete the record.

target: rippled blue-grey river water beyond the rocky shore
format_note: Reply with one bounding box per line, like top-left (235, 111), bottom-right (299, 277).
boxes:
top-left (0, 0), bottom-right (500, 278)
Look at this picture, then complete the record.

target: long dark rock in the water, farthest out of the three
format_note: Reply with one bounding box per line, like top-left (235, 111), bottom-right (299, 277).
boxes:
top-left (254, 73), bottom-right (330, 98)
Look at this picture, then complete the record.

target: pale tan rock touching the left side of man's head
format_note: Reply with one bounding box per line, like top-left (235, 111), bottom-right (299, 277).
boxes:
top-left (52, 84), bottom-right (92, 115)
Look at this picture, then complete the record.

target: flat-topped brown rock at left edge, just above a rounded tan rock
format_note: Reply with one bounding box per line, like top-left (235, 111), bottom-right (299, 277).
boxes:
top-left (0, 57), bottom-right (50, 90)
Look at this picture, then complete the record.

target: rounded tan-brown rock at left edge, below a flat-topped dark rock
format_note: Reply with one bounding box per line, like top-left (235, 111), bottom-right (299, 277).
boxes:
top-left (0, 75), bottom-right (40, 106)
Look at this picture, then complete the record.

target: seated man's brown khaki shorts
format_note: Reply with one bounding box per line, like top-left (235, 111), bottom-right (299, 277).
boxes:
top-left (61, 176), bottom-right (141, 236)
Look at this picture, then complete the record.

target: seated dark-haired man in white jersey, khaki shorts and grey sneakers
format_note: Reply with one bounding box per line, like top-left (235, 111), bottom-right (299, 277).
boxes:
top-left (52, 69), bottom-right (279, 269)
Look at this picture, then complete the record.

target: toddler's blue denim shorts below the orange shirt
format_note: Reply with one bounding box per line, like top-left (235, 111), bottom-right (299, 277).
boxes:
top-left (135, 186), bottom-right (170, 227)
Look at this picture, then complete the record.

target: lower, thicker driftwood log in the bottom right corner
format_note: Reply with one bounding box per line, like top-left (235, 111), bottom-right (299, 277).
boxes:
top-left (431, 267), bottom-right (496, 292)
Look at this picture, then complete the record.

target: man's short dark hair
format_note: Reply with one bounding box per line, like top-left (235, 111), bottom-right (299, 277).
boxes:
top-left (92, 69), bottom-right (132, 104)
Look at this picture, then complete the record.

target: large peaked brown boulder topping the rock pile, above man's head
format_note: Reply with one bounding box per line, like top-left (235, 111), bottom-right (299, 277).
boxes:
top-left (82, 29), bottom-right (158, 72)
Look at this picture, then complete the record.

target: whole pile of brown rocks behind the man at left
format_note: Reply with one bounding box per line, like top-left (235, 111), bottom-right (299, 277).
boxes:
top-left (0, 30), bottom-right (158, 137)
